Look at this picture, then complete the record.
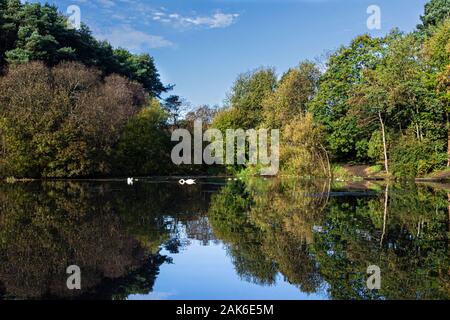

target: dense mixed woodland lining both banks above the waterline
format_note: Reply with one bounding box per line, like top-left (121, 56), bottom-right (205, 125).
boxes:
top-left (0, 0), bottom-right (450, 178)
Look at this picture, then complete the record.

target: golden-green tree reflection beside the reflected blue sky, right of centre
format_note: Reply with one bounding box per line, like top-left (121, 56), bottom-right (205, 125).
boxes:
top-left (210, 180), bottom-right (326, 292)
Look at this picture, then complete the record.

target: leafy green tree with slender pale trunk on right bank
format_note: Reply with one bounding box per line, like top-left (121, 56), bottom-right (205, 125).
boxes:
top-left (349, 33), bottom-right (443, 173)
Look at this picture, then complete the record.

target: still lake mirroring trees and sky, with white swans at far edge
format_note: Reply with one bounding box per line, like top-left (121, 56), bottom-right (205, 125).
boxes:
top-left (0, 178), bottom-right (450, 300)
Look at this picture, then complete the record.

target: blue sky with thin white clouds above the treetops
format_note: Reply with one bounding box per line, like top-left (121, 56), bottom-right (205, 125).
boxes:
top-left (32, 0), bottom-right (427, 107)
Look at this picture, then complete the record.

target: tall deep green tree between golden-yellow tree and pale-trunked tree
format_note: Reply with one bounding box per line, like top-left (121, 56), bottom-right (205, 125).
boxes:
top-left (310, 35), bottom-right (383, 161)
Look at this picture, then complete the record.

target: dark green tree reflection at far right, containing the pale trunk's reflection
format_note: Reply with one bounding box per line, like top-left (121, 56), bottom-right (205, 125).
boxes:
top-left (314, 185), bottom-right (450, 299)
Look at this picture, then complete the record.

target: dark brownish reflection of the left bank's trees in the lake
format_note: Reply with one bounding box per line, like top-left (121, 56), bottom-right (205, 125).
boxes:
top-left (0, 182), bottom-right (211, 299)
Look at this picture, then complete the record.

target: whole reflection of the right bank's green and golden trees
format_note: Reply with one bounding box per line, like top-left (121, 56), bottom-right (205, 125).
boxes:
top-left (210, 180), bottom-right (450, 299)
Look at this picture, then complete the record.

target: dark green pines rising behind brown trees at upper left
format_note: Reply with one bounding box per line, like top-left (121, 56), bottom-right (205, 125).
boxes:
top-left (0, 0), bottom-right (168, 97)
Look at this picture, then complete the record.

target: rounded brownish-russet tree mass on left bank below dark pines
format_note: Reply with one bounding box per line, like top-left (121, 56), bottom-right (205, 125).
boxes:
top-left (0, 62), bottom-right (146, 177)
